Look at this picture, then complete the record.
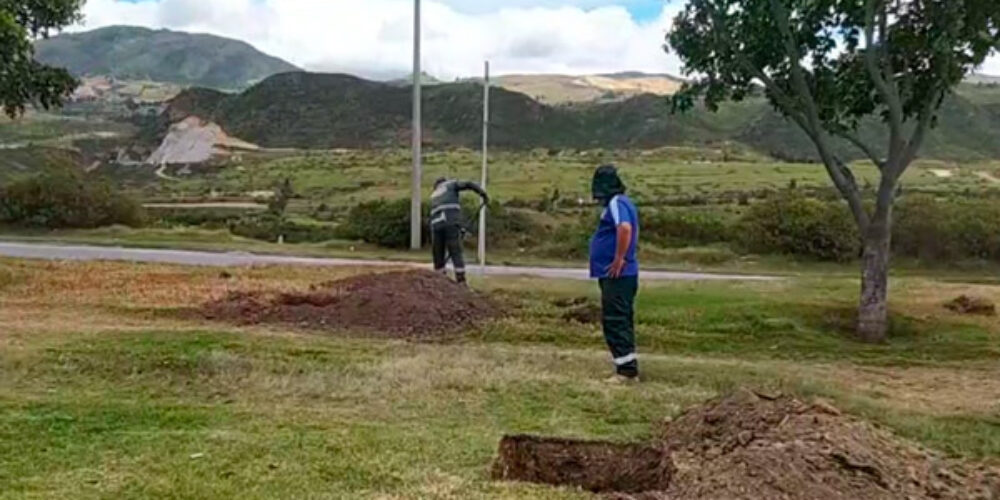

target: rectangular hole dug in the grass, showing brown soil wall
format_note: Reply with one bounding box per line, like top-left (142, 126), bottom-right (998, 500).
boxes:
top-left (493, 436), bottom-right (673, 493)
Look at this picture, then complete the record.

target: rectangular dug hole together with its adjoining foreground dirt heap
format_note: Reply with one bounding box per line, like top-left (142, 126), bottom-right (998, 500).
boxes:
top-left (494, 390), bottom-right (1000, 500)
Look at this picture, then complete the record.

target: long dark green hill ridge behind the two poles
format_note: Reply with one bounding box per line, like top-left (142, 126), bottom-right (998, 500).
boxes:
top-left (154, 73), bottom-right (1000, 160)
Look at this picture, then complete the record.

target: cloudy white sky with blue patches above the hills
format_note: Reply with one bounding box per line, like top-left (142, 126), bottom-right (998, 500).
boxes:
top-left (73, 0), bottom-right (1000, 78)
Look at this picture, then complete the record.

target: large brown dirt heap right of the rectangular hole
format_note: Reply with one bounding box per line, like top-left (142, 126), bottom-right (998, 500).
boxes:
top-left (663, 390), bottom-right (1000, 500)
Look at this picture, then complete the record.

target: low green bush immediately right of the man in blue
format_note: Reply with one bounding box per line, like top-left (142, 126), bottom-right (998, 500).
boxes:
top-left (642, 209), bottom-right (730, 248)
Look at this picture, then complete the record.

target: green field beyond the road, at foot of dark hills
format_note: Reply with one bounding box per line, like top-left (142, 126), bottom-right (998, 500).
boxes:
top-left (129, 148), bottom-right (1000, 210)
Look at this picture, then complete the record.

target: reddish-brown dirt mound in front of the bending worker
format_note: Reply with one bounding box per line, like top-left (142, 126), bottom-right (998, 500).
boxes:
top-left (201, 271), bottom-right (500, 338)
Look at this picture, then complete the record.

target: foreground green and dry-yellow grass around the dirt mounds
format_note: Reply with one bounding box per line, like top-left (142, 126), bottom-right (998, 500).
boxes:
top-left (0, 259), bottom-right (1000, 499)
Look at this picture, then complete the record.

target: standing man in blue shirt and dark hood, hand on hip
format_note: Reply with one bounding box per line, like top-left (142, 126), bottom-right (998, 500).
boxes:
top-left (590, 165), bottom-right (639, 383)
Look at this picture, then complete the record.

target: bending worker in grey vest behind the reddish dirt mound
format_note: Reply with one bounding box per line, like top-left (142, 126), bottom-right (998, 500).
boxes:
top-left (431, 177), bottom-right (490, 284)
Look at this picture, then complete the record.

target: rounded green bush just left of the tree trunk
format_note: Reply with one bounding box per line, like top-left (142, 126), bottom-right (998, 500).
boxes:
top-left (734, 193), bottom-right (859, 261)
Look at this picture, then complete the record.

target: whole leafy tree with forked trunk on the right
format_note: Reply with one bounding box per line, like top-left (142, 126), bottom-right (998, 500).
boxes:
top-left (666, 0), bottom-right (1000, 342)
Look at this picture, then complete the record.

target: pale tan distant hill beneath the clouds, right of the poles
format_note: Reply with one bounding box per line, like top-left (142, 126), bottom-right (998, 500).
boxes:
top-left (496, 72), bottom-right (683, 105)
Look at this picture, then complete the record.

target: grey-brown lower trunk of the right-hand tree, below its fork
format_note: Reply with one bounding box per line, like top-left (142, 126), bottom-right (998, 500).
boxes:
top-left (857, 210), bottom-right (892, 343)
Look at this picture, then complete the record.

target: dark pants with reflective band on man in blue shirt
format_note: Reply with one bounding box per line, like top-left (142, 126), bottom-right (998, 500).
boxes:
top-left (598, 276), bottom-right (639, 377)
